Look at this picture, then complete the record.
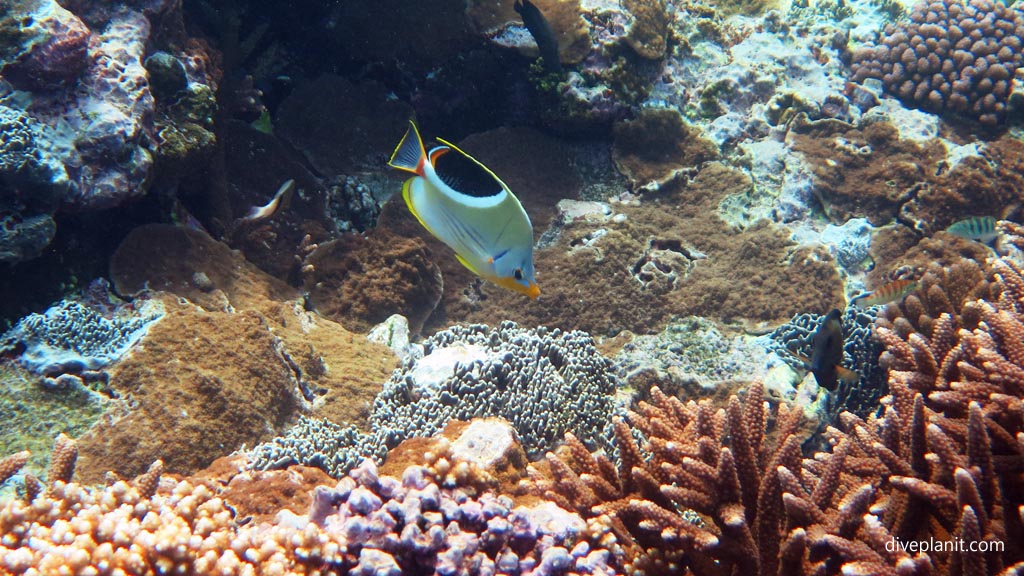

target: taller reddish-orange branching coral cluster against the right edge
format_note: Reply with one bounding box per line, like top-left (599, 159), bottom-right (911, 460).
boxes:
top-left (834, 259), bottom-right (1024, 574)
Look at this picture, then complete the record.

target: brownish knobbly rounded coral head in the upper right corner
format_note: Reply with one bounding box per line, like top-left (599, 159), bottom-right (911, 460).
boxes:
top-left (852, 0), bottom-right (1024, 128)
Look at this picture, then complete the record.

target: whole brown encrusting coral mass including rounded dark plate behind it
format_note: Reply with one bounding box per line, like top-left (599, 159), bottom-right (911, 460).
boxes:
top-left (73, 224), bottom-right (396, 482)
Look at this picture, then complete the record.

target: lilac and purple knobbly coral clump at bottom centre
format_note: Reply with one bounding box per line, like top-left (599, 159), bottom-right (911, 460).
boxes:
top-left (300, 460), bottom-right (614, 576)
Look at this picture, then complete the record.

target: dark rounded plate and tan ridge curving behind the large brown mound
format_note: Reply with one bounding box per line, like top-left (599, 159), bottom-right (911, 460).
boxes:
top-left (111, 224), bottom-right (397, 422)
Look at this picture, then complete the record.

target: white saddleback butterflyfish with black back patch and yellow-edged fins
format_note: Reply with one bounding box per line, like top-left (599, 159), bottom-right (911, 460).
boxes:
top-left (388, 121), bottom-right (541, 298)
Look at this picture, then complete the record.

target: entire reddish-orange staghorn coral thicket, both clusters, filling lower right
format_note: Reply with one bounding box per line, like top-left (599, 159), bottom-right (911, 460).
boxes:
top-left (531, 259), bottom-right (1024, 576)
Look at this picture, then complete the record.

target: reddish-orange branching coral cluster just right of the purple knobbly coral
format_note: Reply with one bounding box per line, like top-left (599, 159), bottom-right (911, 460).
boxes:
top-left (529, 383), bottom-right (815, 575)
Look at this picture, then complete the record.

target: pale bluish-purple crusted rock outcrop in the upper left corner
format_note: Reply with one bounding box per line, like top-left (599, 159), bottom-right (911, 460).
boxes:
top-left (0, 0), bottom-right (216, 262)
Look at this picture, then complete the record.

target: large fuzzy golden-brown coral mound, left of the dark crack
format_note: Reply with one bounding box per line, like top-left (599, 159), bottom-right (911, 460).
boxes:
top-left (73, 298), bottom-right (300, 482)
